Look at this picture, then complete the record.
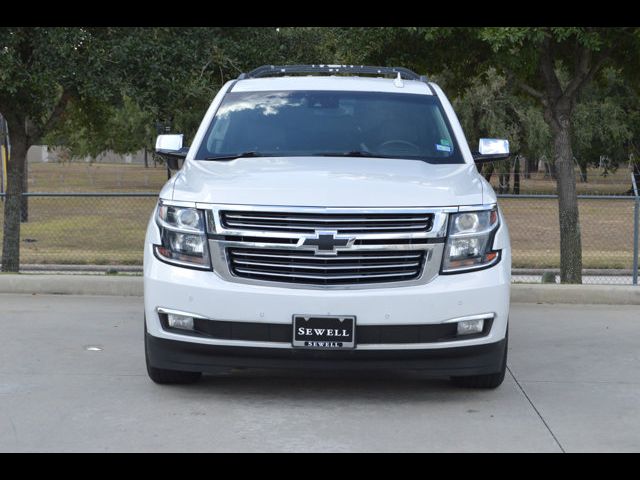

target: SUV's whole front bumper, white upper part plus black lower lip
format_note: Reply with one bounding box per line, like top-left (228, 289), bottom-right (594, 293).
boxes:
top-left (144, 209), bottom-right (511, 364)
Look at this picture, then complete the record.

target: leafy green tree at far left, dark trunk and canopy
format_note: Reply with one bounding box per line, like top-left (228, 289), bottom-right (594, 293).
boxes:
top-left (0, 27), bottom-right (234, 272)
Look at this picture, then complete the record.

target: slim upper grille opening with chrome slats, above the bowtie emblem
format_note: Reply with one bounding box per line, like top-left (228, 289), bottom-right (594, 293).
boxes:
top-left (220, 210), bottom-right (433, 234)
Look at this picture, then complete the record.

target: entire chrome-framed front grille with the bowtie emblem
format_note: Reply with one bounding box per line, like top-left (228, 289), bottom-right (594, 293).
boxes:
top-left (208, 205), bottom-right (449, 289)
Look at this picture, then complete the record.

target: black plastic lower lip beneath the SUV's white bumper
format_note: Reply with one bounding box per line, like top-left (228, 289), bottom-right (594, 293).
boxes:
top-left (145, 333), bottom-right (505, 376)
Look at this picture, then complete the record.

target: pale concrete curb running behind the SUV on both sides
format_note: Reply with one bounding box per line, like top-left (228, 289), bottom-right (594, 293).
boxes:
top-left (0, 274), bottom-right (640, 305)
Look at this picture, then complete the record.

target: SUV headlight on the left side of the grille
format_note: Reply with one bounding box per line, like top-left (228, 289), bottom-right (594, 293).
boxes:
top-left (153, 204), bottom-right (211, 270)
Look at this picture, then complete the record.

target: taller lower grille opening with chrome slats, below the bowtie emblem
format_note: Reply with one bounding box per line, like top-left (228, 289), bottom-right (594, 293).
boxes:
top-left (227, 248), bottom-right (425, 285)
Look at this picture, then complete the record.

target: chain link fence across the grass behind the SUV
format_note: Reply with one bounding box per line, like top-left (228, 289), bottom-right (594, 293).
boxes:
top-left (0, 189), bottom-right (638, 284)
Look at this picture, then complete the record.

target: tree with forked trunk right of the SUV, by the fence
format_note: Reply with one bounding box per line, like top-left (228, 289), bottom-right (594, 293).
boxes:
top-left (479, 27), bottom-right (640, 283)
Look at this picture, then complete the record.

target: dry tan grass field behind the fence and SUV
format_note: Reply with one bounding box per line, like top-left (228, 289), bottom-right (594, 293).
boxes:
top-left (0, 164), bottom-right (633, 268)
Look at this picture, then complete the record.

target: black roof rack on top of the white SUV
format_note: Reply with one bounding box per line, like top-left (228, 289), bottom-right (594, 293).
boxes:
top-left (238, 65), bottom-right (427, 83)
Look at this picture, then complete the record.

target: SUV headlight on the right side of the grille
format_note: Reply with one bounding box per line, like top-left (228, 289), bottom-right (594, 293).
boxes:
top-left (442, 207), bottom-right (500, 273)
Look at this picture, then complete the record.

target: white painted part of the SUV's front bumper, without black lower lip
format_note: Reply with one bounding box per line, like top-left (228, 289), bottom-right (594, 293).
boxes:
top-left (144, 248), bottom-right (510, 342)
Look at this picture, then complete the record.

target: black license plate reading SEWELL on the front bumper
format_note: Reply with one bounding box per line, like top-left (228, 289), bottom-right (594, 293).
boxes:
top-left (293, 315), bottom-right (356, 349)
